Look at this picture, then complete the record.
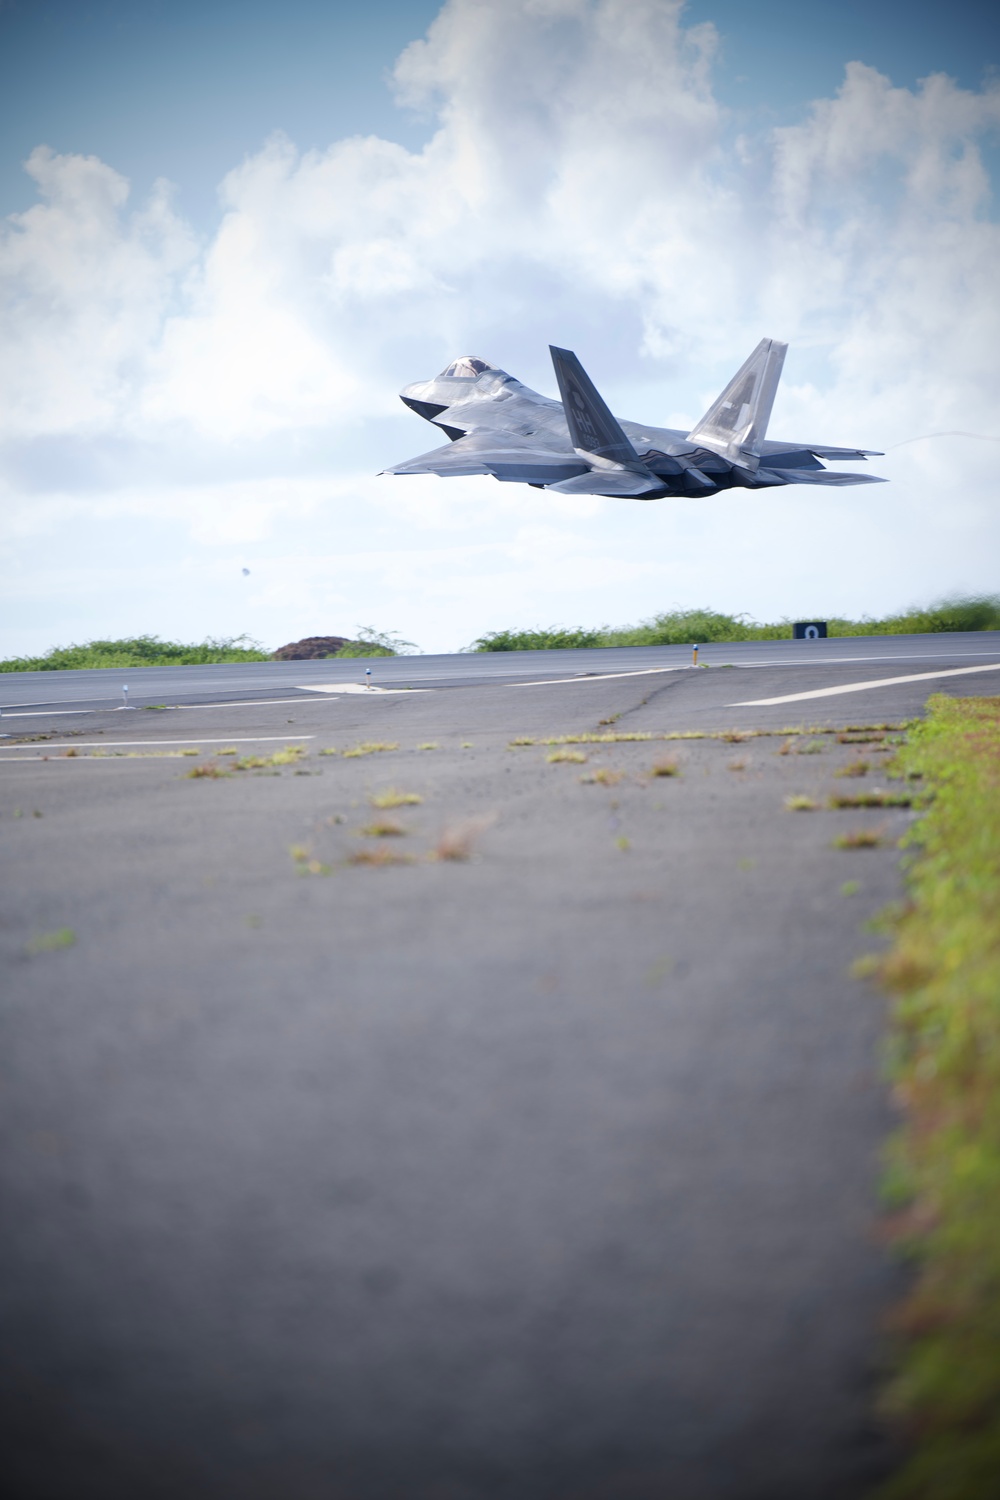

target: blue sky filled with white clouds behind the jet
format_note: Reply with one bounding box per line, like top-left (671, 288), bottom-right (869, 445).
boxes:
top-left (0, 0), bottom-right (1000, 657)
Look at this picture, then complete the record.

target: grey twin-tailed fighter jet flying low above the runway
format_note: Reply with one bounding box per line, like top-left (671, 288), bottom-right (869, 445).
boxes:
top-left (382, 339), bottom-right (882, 500)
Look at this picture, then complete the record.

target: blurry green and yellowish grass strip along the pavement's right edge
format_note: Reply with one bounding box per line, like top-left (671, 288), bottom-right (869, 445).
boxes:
top-left (874, 695), bottom-right (1000, 1500)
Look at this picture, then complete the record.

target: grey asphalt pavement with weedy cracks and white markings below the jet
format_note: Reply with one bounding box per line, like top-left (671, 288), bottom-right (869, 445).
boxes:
top-left (0, 648), bottom-right (1000, 1500)
